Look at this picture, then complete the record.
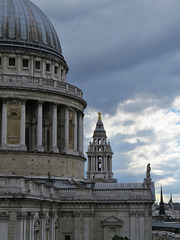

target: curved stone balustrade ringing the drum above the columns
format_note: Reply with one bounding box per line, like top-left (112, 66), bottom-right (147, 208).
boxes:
top-left (0, 74), bottom-right (83, 98)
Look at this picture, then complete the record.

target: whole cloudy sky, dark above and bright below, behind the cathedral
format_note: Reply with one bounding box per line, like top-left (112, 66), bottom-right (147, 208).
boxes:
top-left (32, 0), bottom-right (180, 202)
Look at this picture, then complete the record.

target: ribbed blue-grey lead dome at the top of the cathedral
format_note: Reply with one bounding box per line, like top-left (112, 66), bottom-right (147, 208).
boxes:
top-left (0, 0), bottom-right (63, 58)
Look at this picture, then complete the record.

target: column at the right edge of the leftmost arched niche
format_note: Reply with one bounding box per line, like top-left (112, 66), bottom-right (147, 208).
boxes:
top-left (20, 101), bottom-right (27, 151)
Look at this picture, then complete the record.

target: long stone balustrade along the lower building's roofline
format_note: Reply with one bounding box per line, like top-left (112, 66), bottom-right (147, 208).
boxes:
top-left (0, 177), bottom-right (151, 201)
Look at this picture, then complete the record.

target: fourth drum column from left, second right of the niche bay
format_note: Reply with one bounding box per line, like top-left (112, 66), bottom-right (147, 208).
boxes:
top-left (51, 104), bottom-right (59, 153)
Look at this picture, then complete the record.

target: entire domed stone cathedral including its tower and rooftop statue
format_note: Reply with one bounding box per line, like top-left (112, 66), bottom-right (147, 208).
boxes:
top-left (0, 0), bottom-right (155, 240)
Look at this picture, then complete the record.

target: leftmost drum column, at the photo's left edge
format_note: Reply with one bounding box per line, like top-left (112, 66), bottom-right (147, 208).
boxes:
top-left (1, 99), bottom-right (7, 149)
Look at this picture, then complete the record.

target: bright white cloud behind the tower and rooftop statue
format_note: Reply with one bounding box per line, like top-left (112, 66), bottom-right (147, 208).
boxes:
top-left (85, 97), bottom-right (180, 201)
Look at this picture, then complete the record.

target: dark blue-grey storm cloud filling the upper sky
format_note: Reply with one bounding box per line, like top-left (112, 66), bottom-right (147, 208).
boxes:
top-left (36, 0), bottom-right (180, 112)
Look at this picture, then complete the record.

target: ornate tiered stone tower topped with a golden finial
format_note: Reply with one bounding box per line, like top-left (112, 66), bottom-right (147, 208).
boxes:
top-left (87, 112), bottom-right (115, 182)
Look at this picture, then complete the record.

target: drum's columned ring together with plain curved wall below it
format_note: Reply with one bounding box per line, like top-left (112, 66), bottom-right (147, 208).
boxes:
top-left (0, 97), bottom-right (85, 178)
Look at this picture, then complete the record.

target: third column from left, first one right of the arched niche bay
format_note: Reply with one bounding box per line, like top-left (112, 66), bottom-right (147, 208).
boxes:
top-left (36, 102), bottom-right (44, 152)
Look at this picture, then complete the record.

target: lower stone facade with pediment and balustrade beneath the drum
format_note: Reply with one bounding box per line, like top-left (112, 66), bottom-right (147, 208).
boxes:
top-left (0, 177), bottom-right (153, 240)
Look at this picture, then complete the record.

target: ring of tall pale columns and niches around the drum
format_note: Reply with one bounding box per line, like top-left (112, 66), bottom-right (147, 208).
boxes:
top-left (1, 99), bottom-right (83, 154)
